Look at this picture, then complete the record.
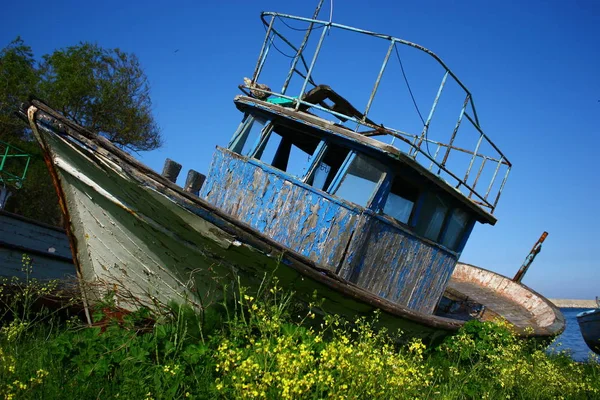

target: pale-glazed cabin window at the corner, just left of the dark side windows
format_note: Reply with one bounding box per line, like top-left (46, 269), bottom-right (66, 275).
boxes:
top-left (333, 154), bottom-right (385, 207)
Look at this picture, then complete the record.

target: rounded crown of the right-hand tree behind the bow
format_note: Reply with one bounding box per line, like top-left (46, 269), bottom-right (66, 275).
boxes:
top-left (40, 43), bottom-right (161, 151)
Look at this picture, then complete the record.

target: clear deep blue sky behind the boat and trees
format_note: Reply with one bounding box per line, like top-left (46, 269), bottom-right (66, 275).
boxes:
top-left (0, 0), bottom-right (600, 298)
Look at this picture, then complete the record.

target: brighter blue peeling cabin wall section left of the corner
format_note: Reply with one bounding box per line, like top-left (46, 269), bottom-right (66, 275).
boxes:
top-left (200, 149), bottom-right (360, 271)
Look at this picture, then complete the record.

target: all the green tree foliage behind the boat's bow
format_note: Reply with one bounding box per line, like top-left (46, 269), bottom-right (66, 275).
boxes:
top-left (0, 37), bottom-right (161, 224)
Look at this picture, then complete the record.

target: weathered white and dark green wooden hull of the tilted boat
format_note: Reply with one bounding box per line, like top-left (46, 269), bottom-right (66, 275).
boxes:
top-left (23, 101), bottom-right (559, 341)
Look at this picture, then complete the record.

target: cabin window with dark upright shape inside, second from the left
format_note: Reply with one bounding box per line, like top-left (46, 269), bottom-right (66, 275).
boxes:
top-left (254, 128), bottom-right (320, 178)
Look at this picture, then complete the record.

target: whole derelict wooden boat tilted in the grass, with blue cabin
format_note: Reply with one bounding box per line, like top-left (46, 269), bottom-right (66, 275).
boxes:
top-left (21, 3), bottom-right (564, 339)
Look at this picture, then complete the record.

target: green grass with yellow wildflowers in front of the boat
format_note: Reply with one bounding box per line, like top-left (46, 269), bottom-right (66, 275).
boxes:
top-left (0, 268), bottom-right (600, 399)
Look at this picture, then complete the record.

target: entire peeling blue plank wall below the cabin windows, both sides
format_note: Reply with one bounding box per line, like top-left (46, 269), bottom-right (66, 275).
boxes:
top-left (200, 148), bottom-right (457, 313)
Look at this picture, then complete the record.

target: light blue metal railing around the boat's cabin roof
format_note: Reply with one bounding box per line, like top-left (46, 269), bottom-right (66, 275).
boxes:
top-left (241, 1), bottom-right (512, 213)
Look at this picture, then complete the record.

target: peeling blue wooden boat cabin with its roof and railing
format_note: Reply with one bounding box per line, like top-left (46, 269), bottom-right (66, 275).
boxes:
top-left (200, 9), bottom-right (510, 314)
